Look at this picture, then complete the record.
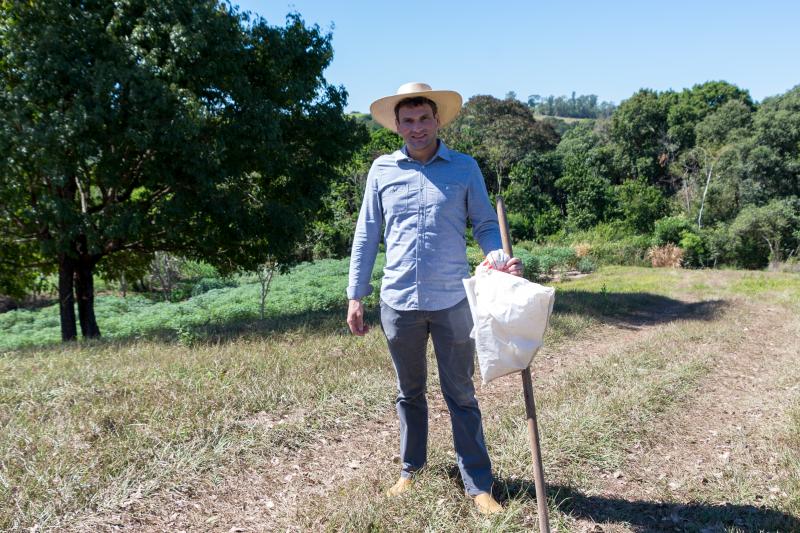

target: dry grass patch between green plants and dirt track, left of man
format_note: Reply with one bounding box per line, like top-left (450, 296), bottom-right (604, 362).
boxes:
top-left (0, 318), bottom-right (393, 530)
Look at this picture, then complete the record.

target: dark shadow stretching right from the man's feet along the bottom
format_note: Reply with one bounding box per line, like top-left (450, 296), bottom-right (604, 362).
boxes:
top-left (493, 479), bottom-right (800, 533)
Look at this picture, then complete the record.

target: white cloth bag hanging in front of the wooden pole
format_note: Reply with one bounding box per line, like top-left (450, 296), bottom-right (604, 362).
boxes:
top-left (462, 267), bottom-right (556, 385)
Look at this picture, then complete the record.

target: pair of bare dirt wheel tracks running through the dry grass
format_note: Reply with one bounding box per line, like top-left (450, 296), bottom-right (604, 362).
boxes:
top-left (76, 288), bottom-right (800, 532)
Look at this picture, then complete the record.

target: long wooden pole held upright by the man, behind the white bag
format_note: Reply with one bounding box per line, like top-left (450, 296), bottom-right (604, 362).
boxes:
top-left (497, 196), bottom-right (550, 533)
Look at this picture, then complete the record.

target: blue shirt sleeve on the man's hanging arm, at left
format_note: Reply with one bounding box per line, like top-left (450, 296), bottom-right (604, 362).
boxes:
top-left (347, 163), bottom-right (383, 300)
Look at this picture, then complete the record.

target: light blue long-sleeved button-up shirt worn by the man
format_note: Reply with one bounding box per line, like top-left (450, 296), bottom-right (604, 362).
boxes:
top-left (347, 141), bottom-right (502, 311)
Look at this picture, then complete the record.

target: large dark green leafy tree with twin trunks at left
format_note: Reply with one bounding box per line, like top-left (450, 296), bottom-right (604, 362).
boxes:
top-left (0, 0), bottom-right (357, 340)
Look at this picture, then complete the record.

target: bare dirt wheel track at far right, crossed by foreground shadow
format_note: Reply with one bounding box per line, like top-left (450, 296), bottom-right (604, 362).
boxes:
top-left (576, 301), bottom-right (800, 533)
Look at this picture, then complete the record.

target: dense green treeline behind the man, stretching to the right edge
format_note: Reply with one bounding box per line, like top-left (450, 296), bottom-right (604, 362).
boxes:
top-left (313, 81), bottom-right (800, 268)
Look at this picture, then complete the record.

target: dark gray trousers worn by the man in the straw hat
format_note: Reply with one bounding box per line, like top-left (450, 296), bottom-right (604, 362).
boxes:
top-left (381, 298), bottom-right (492, 496)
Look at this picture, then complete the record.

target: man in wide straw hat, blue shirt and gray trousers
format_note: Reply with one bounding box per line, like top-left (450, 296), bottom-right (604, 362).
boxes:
top-left (347, 83), bottom-right (522, 514)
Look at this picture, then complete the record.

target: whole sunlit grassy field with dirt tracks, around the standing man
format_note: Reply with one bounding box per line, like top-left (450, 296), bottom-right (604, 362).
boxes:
top-left (0, 263), bottom-right (800, 532)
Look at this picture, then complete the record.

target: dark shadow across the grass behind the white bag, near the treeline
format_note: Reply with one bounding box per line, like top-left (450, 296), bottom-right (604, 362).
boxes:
top-left (553, 290), bottom-right (728, 328)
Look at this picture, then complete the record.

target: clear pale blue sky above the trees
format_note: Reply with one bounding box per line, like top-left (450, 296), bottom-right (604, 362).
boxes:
top-left (232, 0), bottom-right (800, 112)
